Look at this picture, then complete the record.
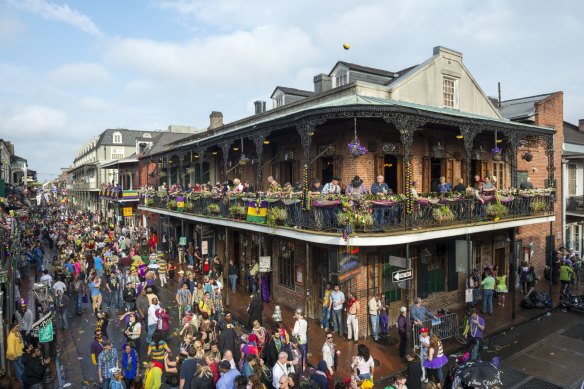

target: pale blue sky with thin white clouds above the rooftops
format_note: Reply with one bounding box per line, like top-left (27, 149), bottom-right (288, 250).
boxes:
top-left (0, 0), bottom-right (584, 181)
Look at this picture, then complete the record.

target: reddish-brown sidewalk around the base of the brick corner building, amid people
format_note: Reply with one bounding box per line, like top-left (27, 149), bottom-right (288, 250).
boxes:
top-left (226, 281), bottom-right (584, 386)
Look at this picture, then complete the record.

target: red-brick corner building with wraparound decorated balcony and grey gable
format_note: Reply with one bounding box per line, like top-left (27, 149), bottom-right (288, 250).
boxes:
top-left (139, 47), bottom-right (562, 335)
